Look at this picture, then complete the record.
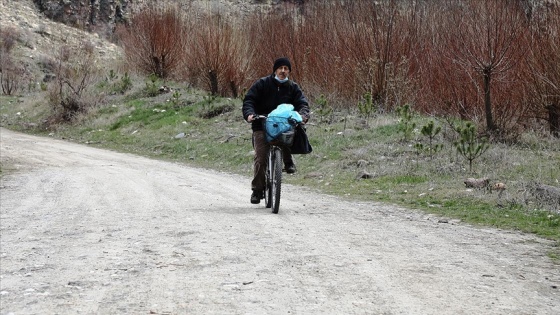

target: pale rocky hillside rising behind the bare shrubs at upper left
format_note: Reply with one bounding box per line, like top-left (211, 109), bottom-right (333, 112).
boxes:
top-left (0, 0), bottom-right (281, 89)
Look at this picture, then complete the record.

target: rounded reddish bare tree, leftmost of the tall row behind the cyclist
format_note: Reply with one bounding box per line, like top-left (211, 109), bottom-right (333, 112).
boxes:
top-left (117, 5), bottom-right (185, 78)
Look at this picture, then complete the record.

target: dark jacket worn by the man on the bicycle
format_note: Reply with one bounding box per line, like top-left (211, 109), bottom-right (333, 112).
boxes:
top-left (243, 74), bottom-right (309, 131)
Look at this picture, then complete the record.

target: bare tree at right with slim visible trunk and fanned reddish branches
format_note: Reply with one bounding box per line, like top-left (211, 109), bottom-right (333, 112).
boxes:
top-left (445, 0), bottom-right (528, 131)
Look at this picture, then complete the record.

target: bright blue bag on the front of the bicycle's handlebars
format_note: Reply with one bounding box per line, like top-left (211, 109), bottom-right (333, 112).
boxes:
top-left (265, 104), bottom-right (303, 142)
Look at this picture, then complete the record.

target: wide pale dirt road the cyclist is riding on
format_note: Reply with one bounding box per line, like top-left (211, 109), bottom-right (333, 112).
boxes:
top-left (0, 129), bottom-right (560, 314)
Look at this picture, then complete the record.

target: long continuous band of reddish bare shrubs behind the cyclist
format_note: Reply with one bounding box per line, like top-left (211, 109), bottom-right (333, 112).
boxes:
top-left (122, 0), bottom-right (560, 136)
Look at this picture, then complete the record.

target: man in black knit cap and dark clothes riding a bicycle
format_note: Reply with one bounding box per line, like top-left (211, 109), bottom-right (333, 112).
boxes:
top-left (243, 57), bottom-right (310, 204)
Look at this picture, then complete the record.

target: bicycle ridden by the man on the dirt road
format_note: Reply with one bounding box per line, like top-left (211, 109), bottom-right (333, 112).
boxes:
top-left (255, 115), bottom-right (297, 213)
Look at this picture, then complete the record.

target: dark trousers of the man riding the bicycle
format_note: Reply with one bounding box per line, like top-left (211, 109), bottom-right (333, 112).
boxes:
top-left (251, 131), bottom-right (294, 190)
